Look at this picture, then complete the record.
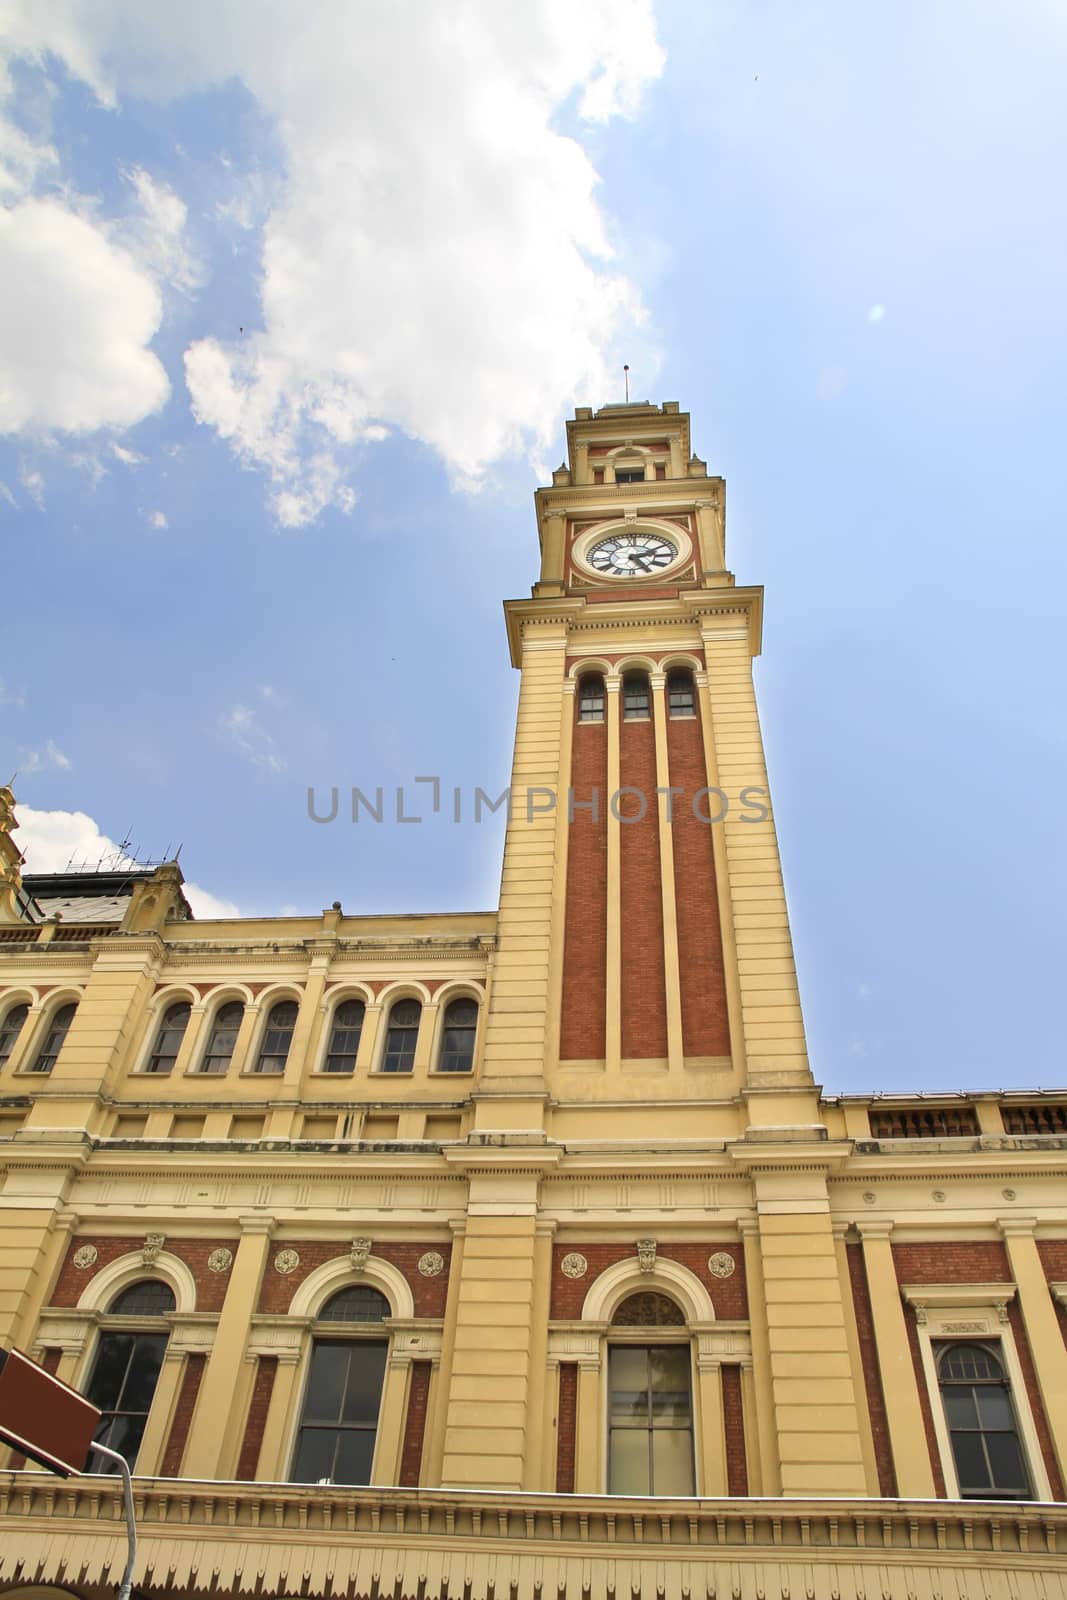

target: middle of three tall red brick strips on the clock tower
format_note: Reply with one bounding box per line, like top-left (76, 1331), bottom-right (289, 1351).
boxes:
top-left (617, 713), bottom-right (667, 1061)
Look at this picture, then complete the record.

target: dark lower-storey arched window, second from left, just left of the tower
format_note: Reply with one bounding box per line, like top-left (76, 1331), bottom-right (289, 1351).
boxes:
top-left (293, 1283), bottom-right (392, 1485)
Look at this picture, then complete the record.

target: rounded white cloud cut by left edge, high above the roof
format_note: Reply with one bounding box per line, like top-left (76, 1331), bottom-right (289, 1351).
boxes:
top-left (0, 198), bottom-right (170, 434)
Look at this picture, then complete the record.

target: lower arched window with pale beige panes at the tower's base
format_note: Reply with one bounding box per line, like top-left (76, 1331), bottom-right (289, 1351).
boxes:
top-left (608, 1293), bottom-right (696, 1494)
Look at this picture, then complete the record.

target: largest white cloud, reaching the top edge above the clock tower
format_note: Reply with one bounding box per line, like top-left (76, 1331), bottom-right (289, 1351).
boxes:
top-left (0, 0), bottom-right (662, 526)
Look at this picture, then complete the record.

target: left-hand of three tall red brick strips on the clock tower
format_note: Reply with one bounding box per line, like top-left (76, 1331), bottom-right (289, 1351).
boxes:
top-left (560, 694), bottom-right (608, 1061)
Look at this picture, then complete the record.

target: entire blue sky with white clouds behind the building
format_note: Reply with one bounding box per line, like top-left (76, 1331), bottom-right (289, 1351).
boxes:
top-left (0, 0), bottom-right (1067, 1090)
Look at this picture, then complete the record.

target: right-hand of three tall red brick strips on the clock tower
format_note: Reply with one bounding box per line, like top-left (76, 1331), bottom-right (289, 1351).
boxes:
top-left (667, 715), bottom-right (729, 1056)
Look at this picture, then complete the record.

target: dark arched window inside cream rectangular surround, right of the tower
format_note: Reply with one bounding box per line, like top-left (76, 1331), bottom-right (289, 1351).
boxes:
top-left (937, 1344), bottom-right (1032, 1499)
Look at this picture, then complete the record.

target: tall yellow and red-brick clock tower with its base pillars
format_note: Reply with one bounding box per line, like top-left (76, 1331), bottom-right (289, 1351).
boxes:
top-left (443, 402), bottom-right (865, 1494)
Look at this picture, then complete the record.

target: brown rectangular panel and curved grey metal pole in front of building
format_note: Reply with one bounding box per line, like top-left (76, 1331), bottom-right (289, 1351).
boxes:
top-left (0, 1350), bottom-right (138, 1600)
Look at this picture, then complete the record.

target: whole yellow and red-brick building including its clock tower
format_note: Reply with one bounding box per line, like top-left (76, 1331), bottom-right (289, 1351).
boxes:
top-left (0, 403), bottom-right (1067, 1600)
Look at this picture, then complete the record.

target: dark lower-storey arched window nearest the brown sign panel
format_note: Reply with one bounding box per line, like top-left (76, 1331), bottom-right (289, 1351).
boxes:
top-left (85, 1278), bottom-right (174, 1472)
